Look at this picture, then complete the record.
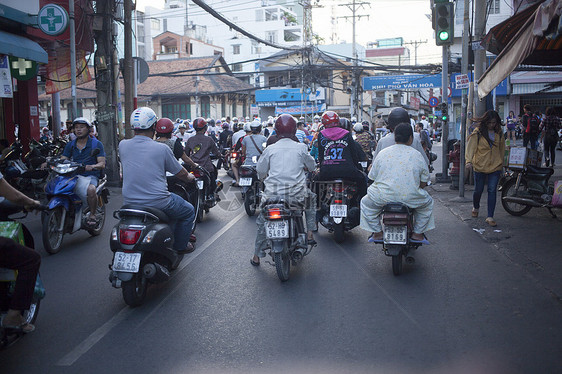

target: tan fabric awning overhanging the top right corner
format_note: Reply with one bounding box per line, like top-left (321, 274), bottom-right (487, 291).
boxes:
top-left (478, 0), bottom-right (562, 98)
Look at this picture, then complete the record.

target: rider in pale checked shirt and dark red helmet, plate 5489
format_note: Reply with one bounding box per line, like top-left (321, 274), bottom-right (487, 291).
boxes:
top-left (250, 114), bottom-right (316, 266)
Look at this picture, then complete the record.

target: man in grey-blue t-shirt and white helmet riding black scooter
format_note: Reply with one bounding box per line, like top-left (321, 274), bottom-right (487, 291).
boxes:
top-left (119, 107), bottom-right (195, 253)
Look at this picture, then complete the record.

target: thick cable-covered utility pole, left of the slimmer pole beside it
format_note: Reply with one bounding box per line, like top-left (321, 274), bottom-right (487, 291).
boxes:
top-left (94, 0), bottom-right (120, 186)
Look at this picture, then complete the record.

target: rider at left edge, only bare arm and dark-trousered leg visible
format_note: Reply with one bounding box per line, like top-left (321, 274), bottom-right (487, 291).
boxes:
top-left (0, 173), bottom-right (41, 333)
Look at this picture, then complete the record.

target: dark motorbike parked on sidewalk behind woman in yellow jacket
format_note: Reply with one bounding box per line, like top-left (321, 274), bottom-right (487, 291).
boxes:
top-left (498, 165), bottom-right (556, 218)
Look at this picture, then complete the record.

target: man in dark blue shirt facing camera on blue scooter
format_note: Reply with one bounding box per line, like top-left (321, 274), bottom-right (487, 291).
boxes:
top-left (61, 117), bottom-right (105, 226)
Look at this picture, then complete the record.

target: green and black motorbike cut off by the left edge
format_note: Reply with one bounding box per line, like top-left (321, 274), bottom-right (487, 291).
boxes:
top-left (0, 200), bottom-right (46, 349)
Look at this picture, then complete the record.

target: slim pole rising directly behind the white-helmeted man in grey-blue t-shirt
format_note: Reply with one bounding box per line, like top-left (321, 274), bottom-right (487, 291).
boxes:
top-left (123, 0), bottom-right (135, 139)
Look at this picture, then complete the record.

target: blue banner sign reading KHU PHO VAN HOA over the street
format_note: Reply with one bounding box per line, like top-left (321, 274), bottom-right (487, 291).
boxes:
top-left (363, 74), bottom-right (441, 91)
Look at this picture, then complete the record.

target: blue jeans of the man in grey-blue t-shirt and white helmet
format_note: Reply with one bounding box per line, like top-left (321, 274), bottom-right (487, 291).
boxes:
top-left (162, 193), bottom-right (195, 251)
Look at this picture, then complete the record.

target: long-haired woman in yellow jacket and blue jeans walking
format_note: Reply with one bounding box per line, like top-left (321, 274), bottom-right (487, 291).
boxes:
top-left (465, 110), bottom-right (505, 226)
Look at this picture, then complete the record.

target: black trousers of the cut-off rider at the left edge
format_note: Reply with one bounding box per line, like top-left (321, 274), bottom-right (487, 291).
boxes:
top-left (0, 237), bottom-right (41, 311)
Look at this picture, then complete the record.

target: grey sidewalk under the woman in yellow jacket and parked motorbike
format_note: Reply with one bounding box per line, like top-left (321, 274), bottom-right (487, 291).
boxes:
top-left (428, 151), bottom-right (562, 300)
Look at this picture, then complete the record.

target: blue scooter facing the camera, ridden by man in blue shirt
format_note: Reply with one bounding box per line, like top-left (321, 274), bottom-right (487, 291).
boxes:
top-left (41, 149), bottom-right (109, 254)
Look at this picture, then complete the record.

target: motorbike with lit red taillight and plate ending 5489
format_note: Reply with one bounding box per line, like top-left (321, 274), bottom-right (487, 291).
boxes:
top-left (262, 197), bottom-right (313, 282)
